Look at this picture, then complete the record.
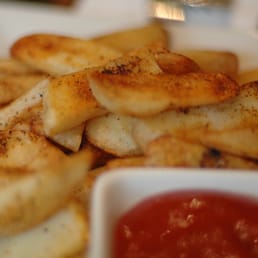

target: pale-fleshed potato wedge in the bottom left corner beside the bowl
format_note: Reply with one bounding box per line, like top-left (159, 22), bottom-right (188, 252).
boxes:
top-left (0, 202), bottom-right (89, 258)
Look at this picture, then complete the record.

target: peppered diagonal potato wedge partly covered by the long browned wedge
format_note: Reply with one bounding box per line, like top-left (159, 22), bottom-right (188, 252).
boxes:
top-left (43, 45), bottom-right (162, 136)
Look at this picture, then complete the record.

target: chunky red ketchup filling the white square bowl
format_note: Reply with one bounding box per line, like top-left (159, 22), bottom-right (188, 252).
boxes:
top-left (113, 191), bottom-right (258, 258)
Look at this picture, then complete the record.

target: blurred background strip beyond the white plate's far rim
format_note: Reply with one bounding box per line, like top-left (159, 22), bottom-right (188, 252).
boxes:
top-left (1, 0), bottom-right (258, 31)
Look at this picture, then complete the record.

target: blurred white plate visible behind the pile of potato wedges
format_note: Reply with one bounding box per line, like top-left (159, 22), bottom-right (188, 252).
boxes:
top-left (0, 4), bottom-right (258, 70)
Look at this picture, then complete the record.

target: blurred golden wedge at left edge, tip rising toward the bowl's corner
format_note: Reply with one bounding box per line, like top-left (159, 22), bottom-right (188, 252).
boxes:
top-left (0, 149), bottom-right (91, 236)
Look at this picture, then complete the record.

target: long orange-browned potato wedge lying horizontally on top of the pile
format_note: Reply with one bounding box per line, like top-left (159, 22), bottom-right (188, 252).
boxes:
top-left (88, 70), bottom-right (239, 116)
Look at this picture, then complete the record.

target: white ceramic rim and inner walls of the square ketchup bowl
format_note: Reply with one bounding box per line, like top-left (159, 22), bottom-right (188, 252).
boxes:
top-left (88, 168), bottom-right (258, 258)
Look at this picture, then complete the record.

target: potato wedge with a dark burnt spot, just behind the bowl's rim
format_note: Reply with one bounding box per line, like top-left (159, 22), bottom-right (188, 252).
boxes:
top-left (144, 135), bottom-right (258, 170)
